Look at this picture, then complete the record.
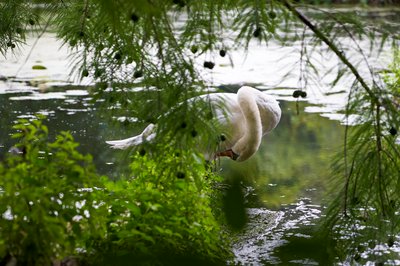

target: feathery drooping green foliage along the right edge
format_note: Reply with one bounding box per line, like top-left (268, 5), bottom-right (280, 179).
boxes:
top-left (326, 52), bottom-right (400, 262)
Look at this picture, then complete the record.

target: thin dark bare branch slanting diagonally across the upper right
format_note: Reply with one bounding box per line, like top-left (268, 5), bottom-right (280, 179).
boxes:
top-left (283, 0), bottom-right (379, 102)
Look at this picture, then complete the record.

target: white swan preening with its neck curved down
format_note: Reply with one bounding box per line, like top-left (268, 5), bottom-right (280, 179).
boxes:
top-left (107, 86), bottom-right (281, 161)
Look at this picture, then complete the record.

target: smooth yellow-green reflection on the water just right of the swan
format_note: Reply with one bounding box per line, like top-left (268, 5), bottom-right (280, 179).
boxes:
top-left (222, 102), bottom-right (344, 209)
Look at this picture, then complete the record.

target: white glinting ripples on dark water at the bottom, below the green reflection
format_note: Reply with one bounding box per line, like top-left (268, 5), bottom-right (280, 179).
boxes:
top-left (234, 202), bottom-right (333, 265)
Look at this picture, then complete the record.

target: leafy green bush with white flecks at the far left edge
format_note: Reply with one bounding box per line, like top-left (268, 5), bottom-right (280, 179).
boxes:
top-left (0, 117), bottom-right (105, 265)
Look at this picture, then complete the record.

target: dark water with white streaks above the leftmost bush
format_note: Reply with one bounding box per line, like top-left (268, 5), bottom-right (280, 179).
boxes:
top-left (0, 88), bottom-right (119, 176)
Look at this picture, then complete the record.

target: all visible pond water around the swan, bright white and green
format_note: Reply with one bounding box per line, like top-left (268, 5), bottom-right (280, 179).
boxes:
top-left (0, 7), bottom-right (400, 265)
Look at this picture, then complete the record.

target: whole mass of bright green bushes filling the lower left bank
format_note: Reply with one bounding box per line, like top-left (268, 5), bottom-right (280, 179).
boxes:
top-left (0, 119), bottom-right (231, 265)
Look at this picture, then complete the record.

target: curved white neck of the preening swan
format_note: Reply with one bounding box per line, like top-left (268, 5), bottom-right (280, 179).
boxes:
top-left (232, 88), bottom-right (262, 161)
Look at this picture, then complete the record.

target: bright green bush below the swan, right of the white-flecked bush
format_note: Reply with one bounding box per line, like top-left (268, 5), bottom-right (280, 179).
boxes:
top-left (87, 147), bottom-right (230, 265)
